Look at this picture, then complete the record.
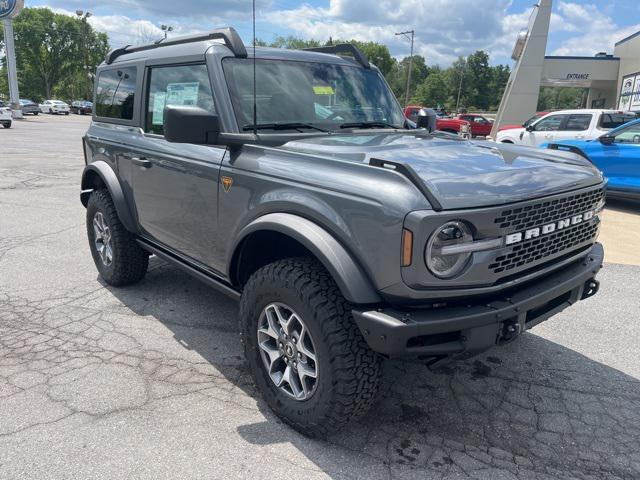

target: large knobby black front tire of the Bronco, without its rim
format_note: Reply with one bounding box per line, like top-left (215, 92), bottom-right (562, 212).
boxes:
top-left (240, 258), bottom-right (381, 438)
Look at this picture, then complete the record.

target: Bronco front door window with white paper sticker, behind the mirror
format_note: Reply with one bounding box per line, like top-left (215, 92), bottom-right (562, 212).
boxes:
top-left (145, 65), bottom-right (215, 135)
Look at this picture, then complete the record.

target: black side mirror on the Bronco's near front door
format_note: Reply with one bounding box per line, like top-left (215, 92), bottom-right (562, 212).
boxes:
top-left (164, 106), bottom-right (220, 145)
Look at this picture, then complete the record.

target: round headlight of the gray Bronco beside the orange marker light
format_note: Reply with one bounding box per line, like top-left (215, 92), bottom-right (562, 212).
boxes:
top-left (425, 222), bottom-right (473, 278)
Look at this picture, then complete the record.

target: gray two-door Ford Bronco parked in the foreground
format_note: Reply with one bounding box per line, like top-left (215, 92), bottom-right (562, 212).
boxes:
top-left (81, 28), bottom-right (605, 436)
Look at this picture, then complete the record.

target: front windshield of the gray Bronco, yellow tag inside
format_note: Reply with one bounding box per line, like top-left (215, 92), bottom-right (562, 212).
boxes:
top-left (223, 58), bottom-right (404, 131)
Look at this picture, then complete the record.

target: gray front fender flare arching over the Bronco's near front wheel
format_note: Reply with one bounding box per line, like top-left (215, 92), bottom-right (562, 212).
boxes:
top-left (232, 213), bottom-right (382, 304)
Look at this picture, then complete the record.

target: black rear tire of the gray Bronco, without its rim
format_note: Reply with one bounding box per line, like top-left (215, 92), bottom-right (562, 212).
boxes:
top-left (87, 189), bottom-right (149, 287)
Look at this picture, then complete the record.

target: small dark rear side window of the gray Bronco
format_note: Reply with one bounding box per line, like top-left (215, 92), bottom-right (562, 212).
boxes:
top-left (96, 67), bottom-right (137, 120)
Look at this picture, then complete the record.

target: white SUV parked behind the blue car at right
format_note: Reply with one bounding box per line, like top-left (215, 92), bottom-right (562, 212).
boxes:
top-left (496, 110), bottom-right (636, 147)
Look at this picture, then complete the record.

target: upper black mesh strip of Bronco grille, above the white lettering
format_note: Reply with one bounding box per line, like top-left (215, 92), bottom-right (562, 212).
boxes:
top-left (494, 188), bottom-right (604, 233)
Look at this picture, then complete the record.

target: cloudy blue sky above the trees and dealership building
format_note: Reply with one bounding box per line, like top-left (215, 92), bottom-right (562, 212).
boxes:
top-left (37, 0), bottom-right (640, 66)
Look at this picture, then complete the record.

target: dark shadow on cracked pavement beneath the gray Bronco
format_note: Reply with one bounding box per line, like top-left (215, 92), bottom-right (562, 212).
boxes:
top-left (110, 259), bottom-right (640, 478)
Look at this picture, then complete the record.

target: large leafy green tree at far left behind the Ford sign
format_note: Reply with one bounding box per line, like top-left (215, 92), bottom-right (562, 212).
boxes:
top-left (0, 8), bottom-right (109, 100)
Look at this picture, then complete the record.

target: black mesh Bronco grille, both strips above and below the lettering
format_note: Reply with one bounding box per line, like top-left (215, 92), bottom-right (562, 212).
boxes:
top-left (489, 188), bottom-right (605, 274)
